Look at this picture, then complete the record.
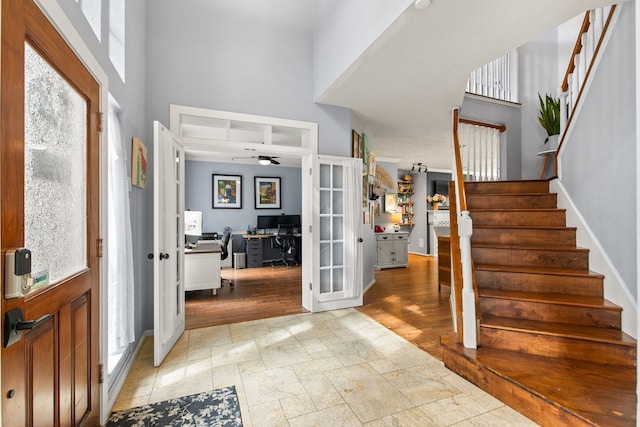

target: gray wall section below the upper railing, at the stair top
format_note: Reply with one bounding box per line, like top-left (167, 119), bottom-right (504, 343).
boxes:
top-left (460, 95), bottom-right (524, 180)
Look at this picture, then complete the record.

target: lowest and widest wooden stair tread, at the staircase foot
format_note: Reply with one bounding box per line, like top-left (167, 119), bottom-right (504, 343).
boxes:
top-left (441, 334), bottom-right (636, 426)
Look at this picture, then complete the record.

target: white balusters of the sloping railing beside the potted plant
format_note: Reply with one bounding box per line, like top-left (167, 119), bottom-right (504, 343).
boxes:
top-left (560, 5), bottom-right (616, 139)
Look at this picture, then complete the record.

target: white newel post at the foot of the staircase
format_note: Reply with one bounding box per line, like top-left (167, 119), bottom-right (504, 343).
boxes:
top-left (458, 211), bottom-right (478, 348)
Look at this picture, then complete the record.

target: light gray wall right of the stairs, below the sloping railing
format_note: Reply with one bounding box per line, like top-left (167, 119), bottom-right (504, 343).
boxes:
top-left (561, 2), bottom-right (638, 298)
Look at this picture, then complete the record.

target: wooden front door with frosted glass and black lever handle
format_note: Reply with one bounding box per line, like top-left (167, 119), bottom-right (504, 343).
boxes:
top-left (0, 0), bottom-right (100, 426)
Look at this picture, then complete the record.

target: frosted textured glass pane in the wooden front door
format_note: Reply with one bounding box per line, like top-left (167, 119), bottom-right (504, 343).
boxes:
top-left (24, 43), bottom-right (87, 283)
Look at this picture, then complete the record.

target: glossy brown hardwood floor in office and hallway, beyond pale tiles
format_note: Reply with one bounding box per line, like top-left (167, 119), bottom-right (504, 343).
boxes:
top-left (186, 255), bottom-right (452, 360)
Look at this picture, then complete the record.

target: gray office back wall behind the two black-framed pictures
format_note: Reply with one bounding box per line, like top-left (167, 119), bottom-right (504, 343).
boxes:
top-left (185, 160), bottom-right (302, 234)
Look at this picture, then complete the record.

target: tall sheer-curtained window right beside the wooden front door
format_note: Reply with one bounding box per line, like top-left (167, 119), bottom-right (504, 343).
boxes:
top-left (107, 101), bottom-right (135, 374)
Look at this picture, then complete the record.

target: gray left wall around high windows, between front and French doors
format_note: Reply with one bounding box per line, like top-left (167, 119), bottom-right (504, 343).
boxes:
top-left (58, 0), bottom-right (153, 348)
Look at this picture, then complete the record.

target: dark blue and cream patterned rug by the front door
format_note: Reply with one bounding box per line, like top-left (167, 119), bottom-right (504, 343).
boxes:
top-left (107, 386), bottom-right (242, 427)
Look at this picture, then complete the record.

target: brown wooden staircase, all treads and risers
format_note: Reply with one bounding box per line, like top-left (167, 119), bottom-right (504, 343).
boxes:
top-left (442, 181), bottom-right (636, 426)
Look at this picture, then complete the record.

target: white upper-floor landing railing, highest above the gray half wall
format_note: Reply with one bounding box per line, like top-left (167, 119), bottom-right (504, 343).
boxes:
top-left (466, 51), bottom-right (518, 102)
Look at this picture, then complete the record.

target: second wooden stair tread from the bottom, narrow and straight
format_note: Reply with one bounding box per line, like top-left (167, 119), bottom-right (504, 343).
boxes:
top-left (480, 315), bottom-right (636, 347)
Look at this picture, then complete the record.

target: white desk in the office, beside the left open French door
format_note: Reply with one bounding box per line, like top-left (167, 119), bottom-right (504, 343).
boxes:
top-left (184, 245), bottom-right (222, 295)
